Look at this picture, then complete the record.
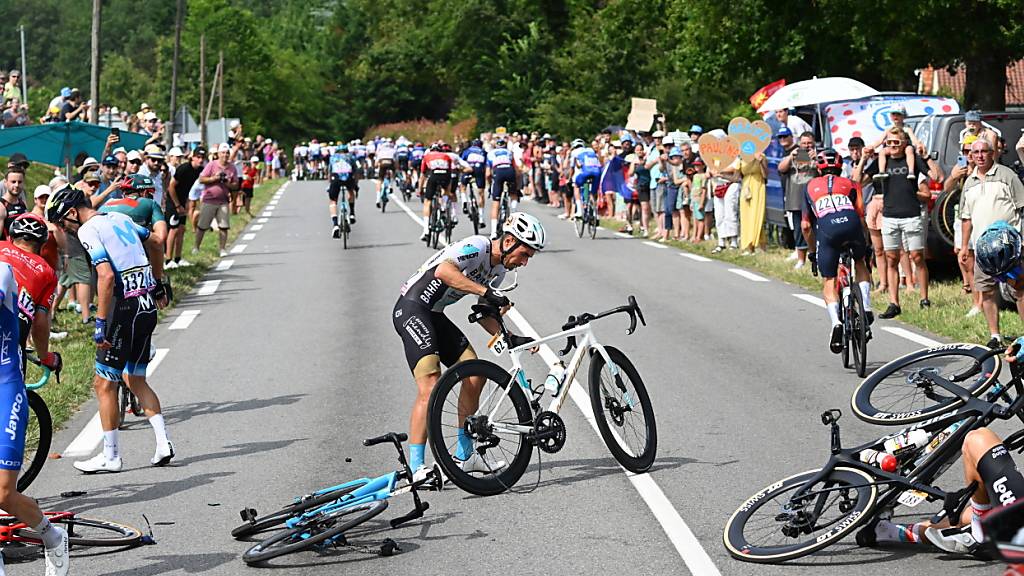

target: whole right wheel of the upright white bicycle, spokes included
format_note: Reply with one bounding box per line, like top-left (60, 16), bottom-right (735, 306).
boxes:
top-left (590, 346), bottom-right (657, 474)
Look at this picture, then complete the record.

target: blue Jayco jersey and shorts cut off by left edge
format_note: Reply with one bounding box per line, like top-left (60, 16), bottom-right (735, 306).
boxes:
top-left (0, 263), bottom-right (29, 470)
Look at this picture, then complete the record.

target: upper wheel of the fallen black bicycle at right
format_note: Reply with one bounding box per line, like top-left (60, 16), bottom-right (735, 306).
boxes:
top-left (850, 343), bottom-right (1002, 424)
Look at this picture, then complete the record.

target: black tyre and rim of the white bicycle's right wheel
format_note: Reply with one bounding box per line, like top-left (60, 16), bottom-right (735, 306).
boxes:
top-left (590, 346), bottom-right (657, 474)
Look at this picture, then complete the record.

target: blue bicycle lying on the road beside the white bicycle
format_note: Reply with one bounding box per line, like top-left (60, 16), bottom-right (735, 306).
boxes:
top-left (231, 433), bottom-right (442, 565)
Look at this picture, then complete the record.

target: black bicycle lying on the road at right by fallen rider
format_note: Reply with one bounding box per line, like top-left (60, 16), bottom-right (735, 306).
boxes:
top-left (723, 344), bottom-right (1024, 564)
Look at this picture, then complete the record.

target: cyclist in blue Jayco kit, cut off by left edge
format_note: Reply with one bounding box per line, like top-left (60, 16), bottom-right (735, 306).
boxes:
top-left (0, 259), bottom-right (70, 576)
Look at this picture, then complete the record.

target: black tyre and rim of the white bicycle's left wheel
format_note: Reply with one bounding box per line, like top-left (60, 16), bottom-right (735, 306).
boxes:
top-left (427, 359), bottom-right (534, 496)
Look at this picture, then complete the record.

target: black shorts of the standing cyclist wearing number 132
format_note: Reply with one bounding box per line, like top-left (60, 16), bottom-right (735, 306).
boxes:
top-left (96, 294), bottom-right (157, 382)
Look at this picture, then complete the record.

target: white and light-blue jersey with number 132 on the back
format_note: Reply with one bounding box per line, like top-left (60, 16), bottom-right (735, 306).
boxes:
top-left (78, 212), bottom-right (157, 298)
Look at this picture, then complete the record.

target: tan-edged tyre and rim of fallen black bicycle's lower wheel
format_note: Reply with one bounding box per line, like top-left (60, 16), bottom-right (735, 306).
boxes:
top-left (722, 466), bottom-right (879, 564)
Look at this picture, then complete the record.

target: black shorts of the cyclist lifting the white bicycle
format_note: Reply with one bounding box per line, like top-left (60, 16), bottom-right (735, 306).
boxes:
top-left (391, 296), bottom-right (476, 377)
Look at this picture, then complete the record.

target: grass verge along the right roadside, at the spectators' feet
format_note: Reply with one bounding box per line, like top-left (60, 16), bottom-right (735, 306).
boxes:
top-left (601, 220), bottom-right (1024, 343)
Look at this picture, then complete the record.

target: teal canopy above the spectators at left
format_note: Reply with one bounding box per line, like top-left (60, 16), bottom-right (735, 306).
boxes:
top-left (0, 122), bottom-right (147, 172)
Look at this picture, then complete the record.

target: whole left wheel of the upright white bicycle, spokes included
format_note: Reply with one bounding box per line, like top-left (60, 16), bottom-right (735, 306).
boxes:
top-left (427, 360), bottom-right (534, 496)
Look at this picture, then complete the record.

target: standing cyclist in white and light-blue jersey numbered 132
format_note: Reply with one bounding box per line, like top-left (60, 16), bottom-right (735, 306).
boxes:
top-left (46, 187), bottom-right (174, 474)
